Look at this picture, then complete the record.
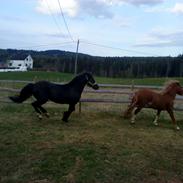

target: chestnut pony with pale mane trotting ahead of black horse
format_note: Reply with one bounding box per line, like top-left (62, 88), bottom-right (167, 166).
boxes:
top-left (124, 80), bottom-right (183, 130)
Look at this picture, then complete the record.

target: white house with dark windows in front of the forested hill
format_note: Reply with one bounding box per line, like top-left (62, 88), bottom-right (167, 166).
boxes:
top-left (8, 55), bottom-right (33, 71)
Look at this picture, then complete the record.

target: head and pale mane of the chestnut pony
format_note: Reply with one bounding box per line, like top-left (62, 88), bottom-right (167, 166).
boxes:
top-left (165, 80), bottom-right (183, 95)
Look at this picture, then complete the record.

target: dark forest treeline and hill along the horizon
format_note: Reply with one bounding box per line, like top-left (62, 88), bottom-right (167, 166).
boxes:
top-left (0, 49), bottom-right (183, 78)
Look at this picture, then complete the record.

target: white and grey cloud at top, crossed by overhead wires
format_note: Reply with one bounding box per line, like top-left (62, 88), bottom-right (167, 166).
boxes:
top-left (36, 0), bottom-right (113, 18)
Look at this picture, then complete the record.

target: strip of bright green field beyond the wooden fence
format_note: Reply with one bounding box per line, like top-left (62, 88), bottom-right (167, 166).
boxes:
top-left (0, 71), bottom-right (183, 86)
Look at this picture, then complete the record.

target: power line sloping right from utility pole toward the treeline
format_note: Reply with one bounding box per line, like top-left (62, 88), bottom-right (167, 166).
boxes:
top-left (80, 40), bottom-right (159, 56)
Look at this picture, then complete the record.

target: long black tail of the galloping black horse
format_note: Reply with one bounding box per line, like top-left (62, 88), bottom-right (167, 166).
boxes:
top-left (9, 83), bottom-right (34, 103)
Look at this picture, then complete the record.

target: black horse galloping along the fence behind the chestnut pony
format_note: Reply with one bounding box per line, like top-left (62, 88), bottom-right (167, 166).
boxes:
top-left (9, 72), bottom-right (99, 122)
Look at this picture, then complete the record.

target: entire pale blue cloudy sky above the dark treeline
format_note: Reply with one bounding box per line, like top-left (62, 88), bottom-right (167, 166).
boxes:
top-left (0, 0), bottom-right (183, 56)
